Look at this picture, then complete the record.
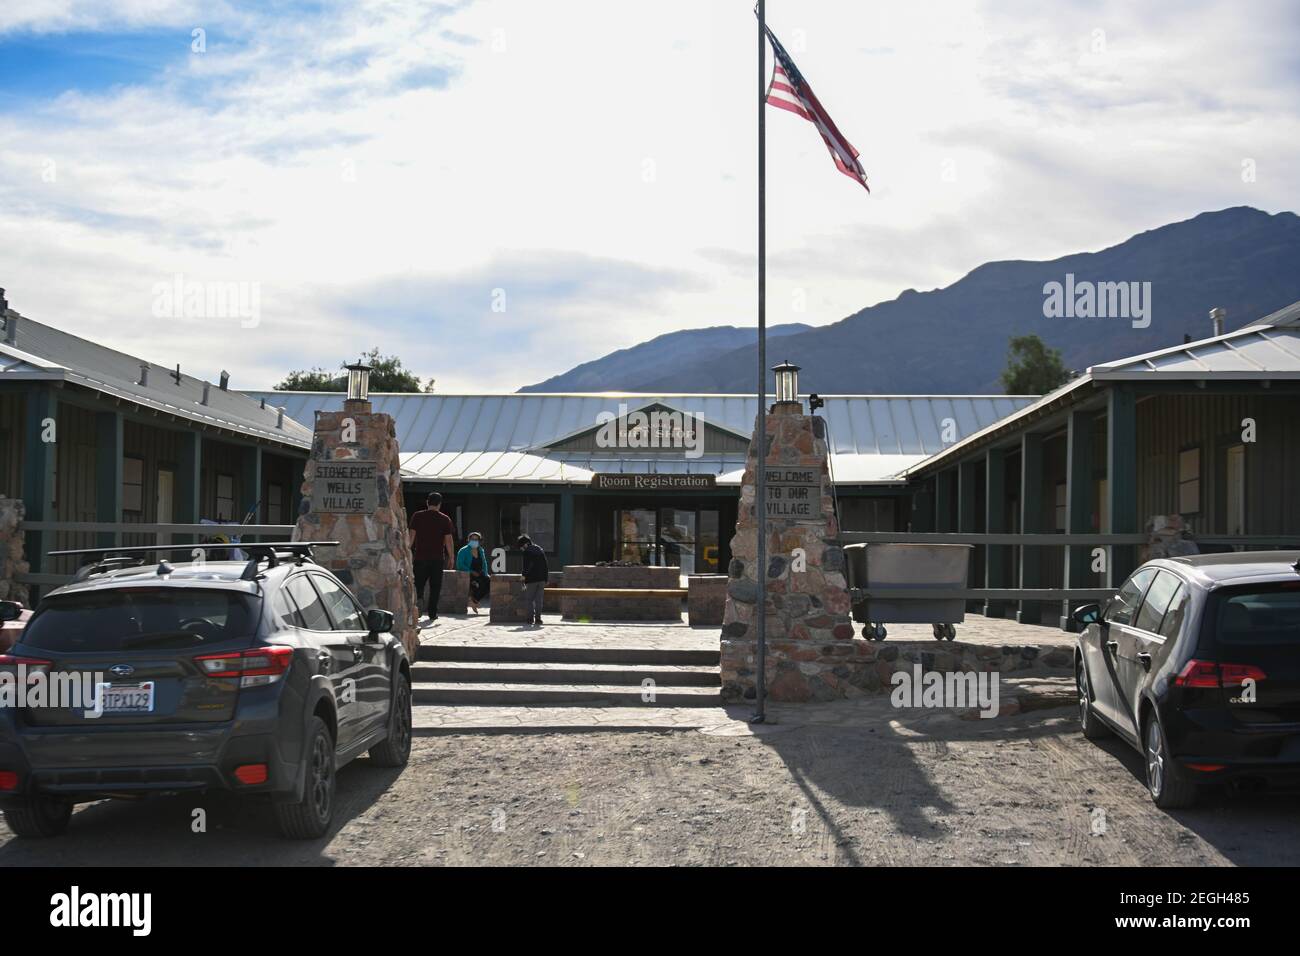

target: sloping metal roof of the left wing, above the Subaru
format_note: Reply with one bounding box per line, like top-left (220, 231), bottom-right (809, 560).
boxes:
top-left (0, 310), bottom-right (312, 449)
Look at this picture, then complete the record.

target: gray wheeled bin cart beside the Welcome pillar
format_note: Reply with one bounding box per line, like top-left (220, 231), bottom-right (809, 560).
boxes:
top-left (844, 544), bottom-right (974, 641)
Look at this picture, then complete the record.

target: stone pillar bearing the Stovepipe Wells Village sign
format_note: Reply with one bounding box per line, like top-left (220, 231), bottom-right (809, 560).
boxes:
top-left (294, 401), bottom-right (420, 661)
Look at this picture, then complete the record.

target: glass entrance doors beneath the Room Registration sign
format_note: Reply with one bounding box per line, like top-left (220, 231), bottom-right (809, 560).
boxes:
top-left (614, 505), bottom-right (720, 575)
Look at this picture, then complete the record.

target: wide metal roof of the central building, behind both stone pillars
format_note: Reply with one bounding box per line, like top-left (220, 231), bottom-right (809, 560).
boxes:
top-left (246, 392), bottom-right (1034, 484)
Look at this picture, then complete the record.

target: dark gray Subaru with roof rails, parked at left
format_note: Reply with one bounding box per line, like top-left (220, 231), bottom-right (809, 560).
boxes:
top-left (0, 544), bottom-right (411, 839)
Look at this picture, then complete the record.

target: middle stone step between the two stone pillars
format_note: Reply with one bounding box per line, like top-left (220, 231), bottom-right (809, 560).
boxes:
top-left (411, 661), bottom-right (720, 687)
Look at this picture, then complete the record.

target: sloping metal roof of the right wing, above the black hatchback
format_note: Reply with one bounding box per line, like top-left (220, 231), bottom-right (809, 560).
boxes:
top-left (1088, 302), bottom-right (1300, 381)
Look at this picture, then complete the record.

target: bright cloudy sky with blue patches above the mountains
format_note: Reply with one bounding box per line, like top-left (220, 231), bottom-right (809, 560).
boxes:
top-left (0, 0), bottom-right (1300, 390)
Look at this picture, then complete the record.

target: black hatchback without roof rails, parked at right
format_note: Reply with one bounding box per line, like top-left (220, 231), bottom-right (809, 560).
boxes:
top-left (1074, 551), bottom-right (1300, 808)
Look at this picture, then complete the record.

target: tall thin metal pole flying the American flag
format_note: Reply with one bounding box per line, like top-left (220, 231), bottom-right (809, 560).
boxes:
top-left (751, 0), bottom-right (767, 723)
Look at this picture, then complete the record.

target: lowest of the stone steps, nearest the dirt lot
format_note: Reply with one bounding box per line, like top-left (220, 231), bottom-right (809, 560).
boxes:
top-left (411, 682), bottom-right (722, 709)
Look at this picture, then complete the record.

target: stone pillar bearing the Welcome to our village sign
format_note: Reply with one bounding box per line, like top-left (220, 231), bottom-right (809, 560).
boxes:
top-left (722, 410), bottom-right (857, 701)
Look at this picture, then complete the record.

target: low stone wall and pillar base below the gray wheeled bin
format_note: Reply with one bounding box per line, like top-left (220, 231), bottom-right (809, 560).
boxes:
top-left (722, 637), bottom-right (1074, 702)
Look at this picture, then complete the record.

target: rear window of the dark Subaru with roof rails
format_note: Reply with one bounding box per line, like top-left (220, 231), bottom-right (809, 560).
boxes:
top-left (22, 588), bottom-right (260, 653)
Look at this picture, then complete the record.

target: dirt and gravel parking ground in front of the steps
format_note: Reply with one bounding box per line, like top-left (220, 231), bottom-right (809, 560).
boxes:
top-left (0, 708), bottom-right (1300, 866)
